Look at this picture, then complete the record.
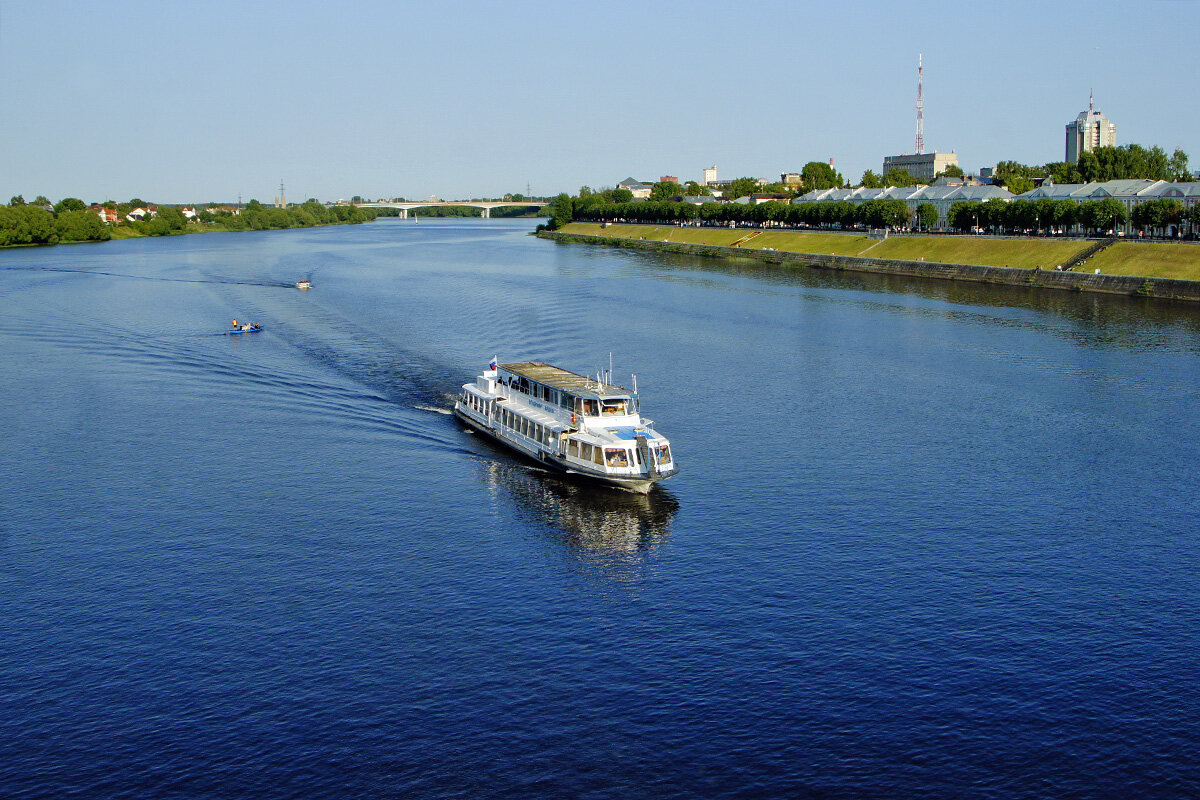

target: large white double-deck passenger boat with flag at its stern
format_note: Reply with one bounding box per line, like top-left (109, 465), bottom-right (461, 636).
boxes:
top-left (454, 359), bottom-right (679, 494)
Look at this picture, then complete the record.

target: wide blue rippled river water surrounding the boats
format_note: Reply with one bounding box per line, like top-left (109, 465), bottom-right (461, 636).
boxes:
top-left (0, 219), bottom-right (1200, 799)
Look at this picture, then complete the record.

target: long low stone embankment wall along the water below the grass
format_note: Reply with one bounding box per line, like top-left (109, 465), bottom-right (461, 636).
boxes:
top-left (538, 231), bottom-right (1200, 302)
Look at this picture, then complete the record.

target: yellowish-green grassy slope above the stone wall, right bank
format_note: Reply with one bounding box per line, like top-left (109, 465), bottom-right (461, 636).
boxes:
top-left (565, 222), bottom-right (1200, 281)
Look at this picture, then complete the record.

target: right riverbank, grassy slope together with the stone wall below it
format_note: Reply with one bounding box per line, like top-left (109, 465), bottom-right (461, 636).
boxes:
top-left (541, 222), bottom-right (1200, 302)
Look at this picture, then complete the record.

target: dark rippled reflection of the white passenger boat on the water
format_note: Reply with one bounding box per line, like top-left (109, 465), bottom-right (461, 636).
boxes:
top-left (472, 459), bottom-right (679, 578)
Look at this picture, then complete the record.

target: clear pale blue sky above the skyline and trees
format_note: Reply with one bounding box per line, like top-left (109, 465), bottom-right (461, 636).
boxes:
top-left (0, 0), bottom-right (1200, 203)
